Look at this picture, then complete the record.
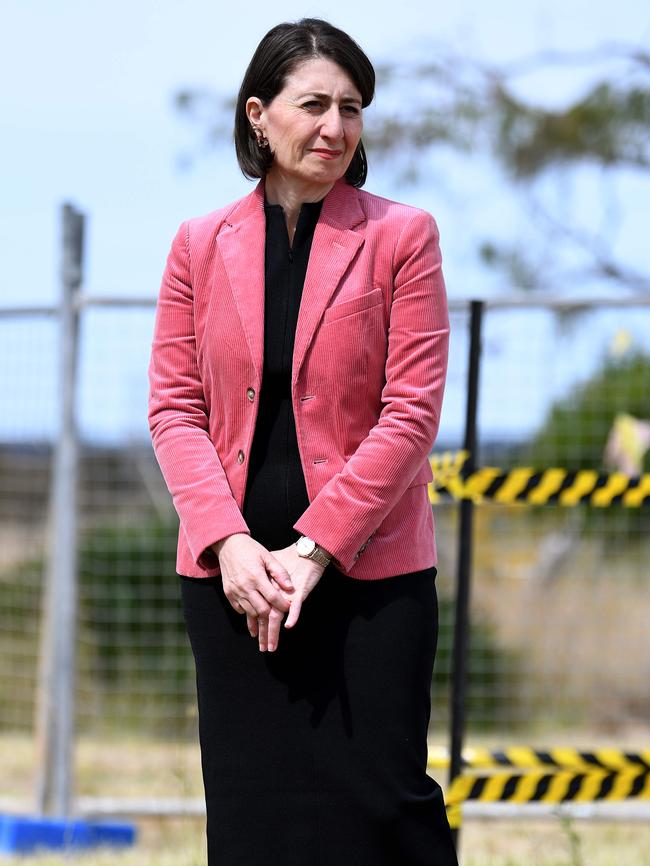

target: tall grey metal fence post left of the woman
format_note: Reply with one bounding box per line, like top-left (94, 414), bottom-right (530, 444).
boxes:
top-left (36, 203), bottom-right (84, 816)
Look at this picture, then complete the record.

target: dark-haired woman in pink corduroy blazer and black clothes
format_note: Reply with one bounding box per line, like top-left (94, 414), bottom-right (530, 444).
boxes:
top-left (149, 19), bottom-right (457, 866)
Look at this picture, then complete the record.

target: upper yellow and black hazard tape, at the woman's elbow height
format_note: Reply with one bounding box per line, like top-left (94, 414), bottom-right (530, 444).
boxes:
top-left (429, 451), bottom-right (650, 508)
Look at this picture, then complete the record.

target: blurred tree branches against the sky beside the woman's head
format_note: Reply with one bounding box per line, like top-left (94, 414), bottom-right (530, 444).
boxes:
top-left (174, 44), bottom-right (650, 292)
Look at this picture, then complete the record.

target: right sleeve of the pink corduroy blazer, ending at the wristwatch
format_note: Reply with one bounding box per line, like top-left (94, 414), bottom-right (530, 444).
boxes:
top-left (294, 210), bottom-right (449, 571)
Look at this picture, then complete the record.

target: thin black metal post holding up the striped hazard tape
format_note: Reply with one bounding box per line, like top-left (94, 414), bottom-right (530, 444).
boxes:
top-left (449, 301), bottom-right (484, 847)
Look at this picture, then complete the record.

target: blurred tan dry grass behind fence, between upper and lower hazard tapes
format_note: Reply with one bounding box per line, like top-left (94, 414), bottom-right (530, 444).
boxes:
top-left (437, 505), bottom-right (650, 731)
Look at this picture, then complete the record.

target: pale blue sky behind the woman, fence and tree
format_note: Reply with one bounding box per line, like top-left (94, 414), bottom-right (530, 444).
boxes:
top-left (0, 0), bottom-right (650, 436)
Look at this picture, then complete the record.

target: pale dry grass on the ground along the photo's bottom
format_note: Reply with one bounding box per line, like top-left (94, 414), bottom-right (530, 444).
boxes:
top-left (0, 727), bottom-right (650, 866)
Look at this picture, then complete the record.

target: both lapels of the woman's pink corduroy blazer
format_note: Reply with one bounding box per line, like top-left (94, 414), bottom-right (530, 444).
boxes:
top-left (217, 178), bottom-right (366, 387)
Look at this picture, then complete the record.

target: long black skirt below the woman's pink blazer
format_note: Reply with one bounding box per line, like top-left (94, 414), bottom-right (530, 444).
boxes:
top-left (181, 565), bottom-right (457, 866)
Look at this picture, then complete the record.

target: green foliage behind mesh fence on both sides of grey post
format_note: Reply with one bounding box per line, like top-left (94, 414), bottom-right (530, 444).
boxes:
top-left (0, 517), bottom-right (196, 736)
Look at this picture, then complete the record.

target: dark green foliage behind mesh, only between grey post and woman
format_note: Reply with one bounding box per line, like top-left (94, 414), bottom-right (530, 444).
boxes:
top-left (78, 518), bottom-right (194, 736)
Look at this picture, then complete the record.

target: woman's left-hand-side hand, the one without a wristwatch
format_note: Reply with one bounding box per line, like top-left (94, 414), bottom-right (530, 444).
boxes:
top-left (212, 532), bottom-right (293, 651)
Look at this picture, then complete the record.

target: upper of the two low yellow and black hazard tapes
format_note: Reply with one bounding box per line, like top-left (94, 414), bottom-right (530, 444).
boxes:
top-left (428, 746), bottom-right (650, 770)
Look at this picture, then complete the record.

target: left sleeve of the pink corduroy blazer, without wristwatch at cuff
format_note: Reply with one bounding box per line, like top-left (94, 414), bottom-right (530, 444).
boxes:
top-left (148, 221), bottom-right (250, 569)
